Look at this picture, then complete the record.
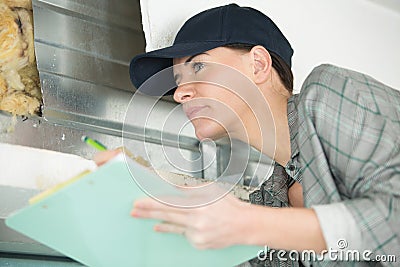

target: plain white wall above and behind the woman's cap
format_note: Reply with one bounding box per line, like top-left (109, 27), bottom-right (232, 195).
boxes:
top-left (141, 0), bottom-right (400, 91)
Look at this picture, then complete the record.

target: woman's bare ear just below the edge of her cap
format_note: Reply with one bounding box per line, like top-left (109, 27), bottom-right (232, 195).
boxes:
top-left (250, 45), bottom-right (272, 84)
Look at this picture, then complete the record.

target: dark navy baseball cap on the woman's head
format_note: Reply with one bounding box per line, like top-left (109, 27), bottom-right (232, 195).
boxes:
top-left (129, 4), bottom-right (293, 96)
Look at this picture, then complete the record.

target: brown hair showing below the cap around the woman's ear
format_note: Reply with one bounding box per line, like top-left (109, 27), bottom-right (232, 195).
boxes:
top-left (224, 43), bottom-right (293, 94)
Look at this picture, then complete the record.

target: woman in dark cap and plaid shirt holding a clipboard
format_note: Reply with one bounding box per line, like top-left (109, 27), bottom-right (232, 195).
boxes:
top-left (97, 4), bottom-right (400, 266)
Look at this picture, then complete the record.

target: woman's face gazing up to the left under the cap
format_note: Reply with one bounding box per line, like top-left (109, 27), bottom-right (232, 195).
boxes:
top-left (174, 47), bottom-right (255, 140)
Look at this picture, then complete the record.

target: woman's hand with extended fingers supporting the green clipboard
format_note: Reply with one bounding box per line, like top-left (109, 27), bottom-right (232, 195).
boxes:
top-left (131, 194), bottom-right (250, 249)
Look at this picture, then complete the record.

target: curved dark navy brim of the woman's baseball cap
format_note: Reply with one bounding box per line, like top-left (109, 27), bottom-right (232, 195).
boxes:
top-left (129, 41), bottom-right (227, 96)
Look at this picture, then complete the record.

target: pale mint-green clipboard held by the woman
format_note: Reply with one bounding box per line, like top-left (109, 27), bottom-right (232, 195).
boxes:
top-left (6, 155), bottom-right (261, 267)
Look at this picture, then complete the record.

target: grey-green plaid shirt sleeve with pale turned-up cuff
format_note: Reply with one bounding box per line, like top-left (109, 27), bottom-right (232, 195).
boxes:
top-left (298, 65), bottom-right (400, 265)
